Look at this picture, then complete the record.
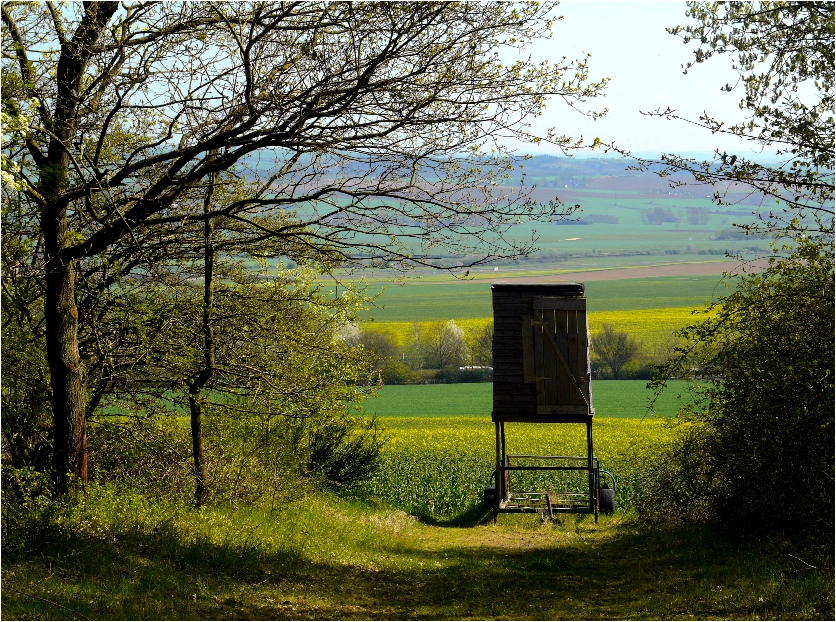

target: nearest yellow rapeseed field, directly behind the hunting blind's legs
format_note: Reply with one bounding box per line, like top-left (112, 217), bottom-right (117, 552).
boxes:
top-left (364, 417), bottom-right (675, 519)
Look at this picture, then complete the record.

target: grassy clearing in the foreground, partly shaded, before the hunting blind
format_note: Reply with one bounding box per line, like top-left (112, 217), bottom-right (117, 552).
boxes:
top-left (2, 486), bottom-right (833, 620)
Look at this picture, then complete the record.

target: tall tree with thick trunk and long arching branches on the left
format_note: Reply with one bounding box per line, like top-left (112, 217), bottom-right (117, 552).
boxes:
top-left (2, 2), bottom-right (603, 486)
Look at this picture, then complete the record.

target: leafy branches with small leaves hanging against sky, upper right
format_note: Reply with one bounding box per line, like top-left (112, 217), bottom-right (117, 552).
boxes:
top-left (619, 2), bottom-right (834, 237)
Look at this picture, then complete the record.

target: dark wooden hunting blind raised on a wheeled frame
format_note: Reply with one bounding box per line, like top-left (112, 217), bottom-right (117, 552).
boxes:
top-left (485, 283), bottom-right (615, 521)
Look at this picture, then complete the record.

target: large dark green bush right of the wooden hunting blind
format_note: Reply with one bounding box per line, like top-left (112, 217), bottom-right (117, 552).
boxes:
top-left (644, 241), bottom-right (836, 542)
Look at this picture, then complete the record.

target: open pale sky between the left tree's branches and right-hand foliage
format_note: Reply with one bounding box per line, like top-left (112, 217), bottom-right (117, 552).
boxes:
top-left (502, 0), bottom-right (754, 161)
